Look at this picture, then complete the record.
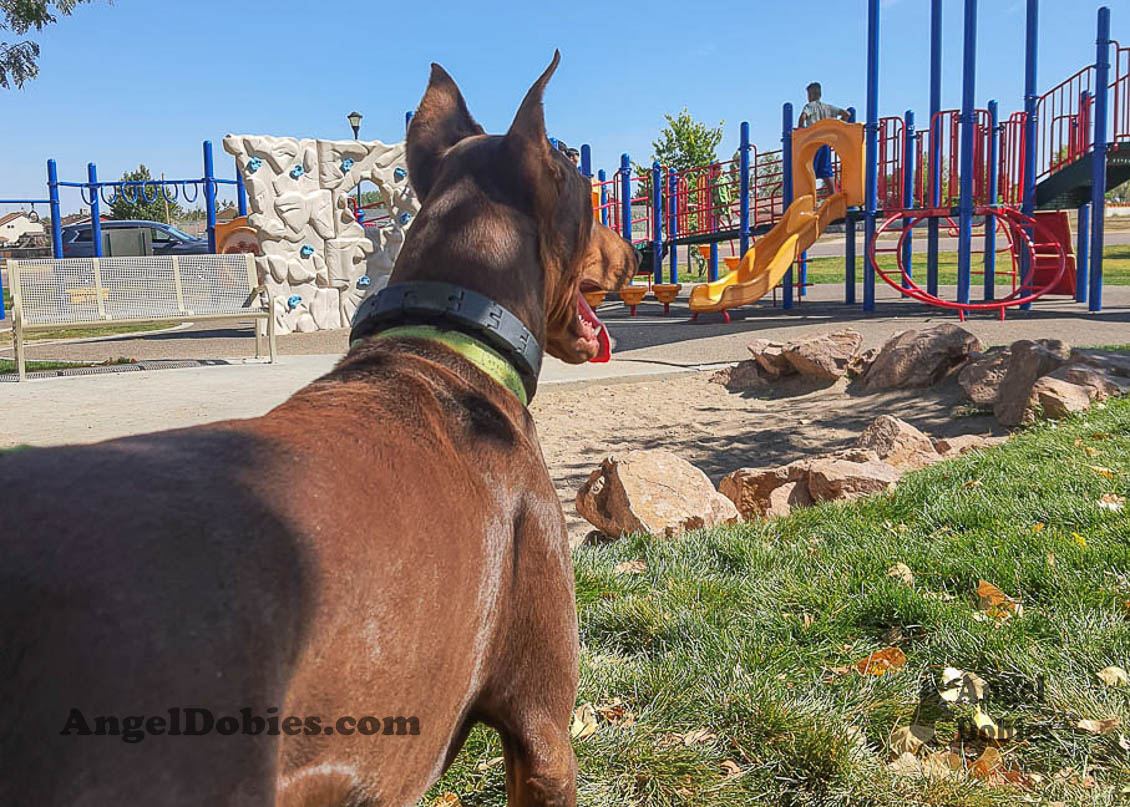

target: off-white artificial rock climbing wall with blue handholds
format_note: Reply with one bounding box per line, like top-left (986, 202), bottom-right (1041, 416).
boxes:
top-left (224, 135), bottom-right (419, 333)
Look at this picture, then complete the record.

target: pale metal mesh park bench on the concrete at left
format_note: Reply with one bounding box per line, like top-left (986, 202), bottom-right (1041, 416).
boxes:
top-left (8, 253), bottom-right (275, 381)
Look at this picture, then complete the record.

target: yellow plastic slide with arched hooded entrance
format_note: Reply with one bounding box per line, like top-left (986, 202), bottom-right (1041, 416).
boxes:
top-left (690, 119), bottom-right (863, 314)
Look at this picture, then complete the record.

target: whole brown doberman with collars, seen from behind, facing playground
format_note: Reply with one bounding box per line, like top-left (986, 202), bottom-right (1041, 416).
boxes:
top-left (0, 54), bottom-right (636, 807)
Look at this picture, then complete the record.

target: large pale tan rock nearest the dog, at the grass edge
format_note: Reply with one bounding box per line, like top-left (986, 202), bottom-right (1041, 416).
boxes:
top-left (576, 450), bottom-right (738, 536)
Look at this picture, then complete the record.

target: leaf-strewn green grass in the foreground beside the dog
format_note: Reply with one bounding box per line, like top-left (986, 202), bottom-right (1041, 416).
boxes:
top-left (425, 400), bottom-right (1130, 807)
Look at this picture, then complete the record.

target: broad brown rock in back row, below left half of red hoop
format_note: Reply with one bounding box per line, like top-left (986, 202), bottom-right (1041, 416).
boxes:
top-left (863, 323), bottom-right (983, 390)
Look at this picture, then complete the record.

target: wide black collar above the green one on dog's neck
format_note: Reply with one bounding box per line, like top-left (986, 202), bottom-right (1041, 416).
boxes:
top-left (349, 281), bottom-right (541, 399)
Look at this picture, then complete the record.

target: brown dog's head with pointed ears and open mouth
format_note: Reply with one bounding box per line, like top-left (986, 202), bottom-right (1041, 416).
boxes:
top-left (391, 53), bottom-right (638, 364)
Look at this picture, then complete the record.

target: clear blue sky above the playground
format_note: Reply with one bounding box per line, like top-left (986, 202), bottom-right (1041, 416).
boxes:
top-left (0, 0), bottom-right (1111, 210)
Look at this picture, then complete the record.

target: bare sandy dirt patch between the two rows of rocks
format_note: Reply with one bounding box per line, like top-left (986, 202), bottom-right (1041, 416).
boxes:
top-left (530, 372), bottom-right (999, 543)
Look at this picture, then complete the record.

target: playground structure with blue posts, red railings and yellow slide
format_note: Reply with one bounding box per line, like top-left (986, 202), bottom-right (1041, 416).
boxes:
top-left (581, 0), bottom-right (1130, 321)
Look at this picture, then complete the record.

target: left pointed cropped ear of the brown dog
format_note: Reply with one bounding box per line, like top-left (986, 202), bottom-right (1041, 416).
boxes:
top-left (406, 62), bottom-right (483, 201)
